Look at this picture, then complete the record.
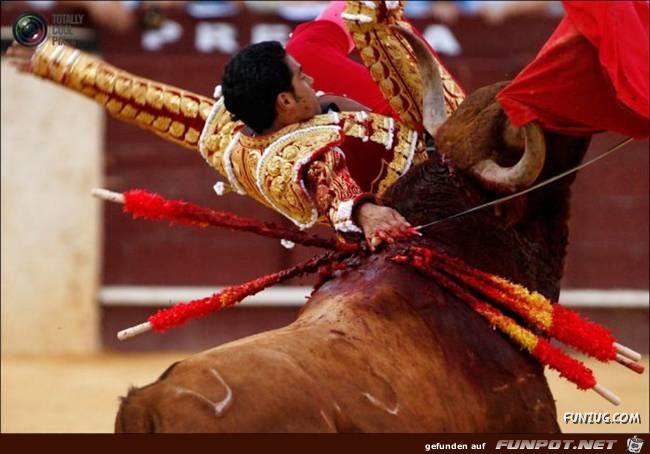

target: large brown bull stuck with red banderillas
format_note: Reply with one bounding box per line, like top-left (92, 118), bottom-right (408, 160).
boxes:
top-left (115, 85), bottom-right (588, 432)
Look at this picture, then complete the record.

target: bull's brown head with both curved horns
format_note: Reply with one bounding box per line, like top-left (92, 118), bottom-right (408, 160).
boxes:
top-left (397, 27), bottom-right (546, 193)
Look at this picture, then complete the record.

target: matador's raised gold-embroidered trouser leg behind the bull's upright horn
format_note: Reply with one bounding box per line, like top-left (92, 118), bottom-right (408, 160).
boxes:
top-left (343, 1), bottom-right (465, 130)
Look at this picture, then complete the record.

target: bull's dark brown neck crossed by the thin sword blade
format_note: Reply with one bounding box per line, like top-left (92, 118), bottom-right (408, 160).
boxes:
top-left (387, 137), bottom-right (588, 299)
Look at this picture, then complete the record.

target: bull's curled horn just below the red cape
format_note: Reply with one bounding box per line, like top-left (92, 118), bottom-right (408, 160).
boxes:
top-left (471, 122), bottom-right (546, 192)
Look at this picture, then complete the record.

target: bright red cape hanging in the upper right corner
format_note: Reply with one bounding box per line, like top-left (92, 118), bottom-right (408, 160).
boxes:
top-left (497, 1), bottom-right (650, 139)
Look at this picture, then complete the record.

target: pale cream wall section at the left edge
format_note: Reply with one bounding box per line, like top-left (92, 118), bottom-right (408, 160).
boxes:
top-left (1, 60), bottom-right (104, 354)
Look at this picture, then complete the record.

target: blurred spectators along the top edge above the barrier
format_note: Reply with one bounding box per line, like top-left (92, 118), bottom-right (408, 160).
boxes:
top-left (2, 0), bottom-right (563, 33)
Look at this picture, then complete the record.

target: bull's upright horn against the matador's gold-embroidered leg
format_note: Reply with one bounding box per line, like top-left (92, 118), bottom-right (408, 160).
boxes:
top-left (395, 26), bottom-right (447, 136)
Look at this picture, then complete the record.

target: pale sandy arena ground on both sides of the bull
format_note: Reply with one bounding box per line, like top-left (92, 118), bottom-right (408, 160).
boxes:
top-left (1, 353), bottom-right (650, 433)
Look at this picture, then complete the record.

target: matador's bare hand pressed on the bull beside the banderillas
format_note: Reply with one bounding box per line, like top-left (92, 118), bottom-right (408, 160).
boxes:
top-left (357, 203), bottom-right (419, 251)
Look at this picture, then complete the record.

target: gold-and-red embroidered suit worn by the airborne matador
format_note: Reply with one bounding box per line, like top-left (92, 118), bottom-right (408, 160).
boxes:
top-left (11, 2), bottom-right (464, 248)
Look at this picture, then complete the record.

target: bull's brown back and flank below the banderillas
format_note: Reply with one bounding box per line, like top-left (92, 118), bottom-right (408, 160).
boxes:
top-left (116, 274), bottom-right (557, 432)
